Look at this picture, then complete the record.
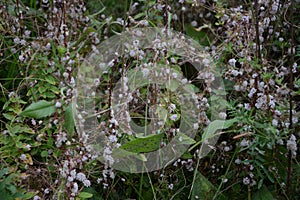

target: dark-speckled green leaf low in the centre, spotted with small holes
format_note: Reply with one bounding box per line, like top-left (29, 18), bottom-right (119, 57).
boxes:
top-left (120, 134), bottom-right (164, 153)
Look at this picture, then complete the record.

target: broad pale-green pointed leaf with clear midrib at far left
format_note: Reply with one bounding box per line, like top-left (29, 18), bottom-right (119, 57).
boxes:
top-left (21, 100), bottom-right (56, 119)
